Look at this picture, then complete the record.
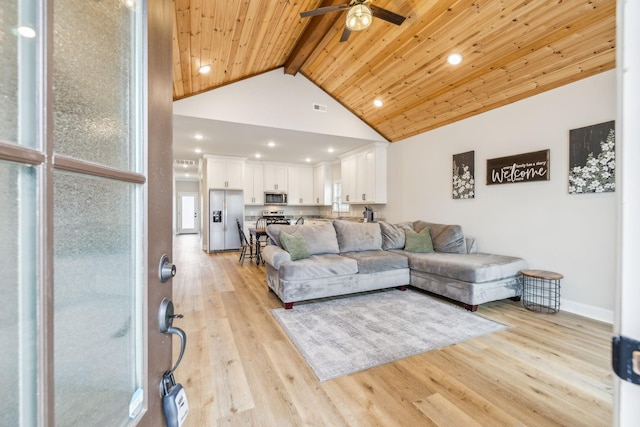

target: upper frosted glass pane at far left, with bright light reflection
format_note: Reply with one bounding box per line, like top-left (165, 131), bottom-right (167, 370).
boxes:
top-left (0, 1), bottom-right (37, 147)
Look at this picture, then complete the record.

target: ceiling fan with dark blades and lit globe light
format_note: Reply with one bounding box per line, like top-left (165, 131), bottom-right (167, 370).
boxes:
top-left (300, 0), bottom-right (406, 42)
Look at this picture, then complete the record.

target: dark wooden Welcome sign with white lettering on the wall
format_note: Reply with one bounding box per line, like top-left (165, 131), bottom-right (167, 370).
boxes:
top-left (487, 150), bottom-right (549, 185)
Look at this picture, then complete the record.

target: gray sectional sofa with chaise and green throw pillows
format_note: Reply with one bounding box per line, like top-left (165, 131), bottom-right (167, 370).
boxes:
top-left (263, 220), bottom-right (527, 311)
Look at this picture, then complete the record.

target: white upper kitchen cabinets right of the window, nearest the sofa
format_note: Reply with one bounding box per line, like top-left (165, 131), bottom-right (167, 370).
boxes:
top-left (340, 142), bottom-right (389, 203)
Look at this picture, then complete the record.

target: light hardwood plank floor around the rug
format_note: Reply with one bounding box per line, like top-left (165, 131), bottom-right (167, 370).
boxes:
top-left (173, 235), bottom-right (613, 427)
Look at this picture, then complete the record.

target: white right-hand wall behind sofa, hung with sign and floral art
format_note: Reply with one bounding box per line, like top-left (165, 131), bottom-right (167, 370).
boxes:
top-left (381, 71), bottom-right (617, 322)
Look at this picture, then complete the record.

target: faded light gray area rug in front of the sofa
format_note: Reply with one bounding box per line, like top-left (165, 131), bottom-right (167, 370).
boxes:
top-left (271, 289), bottom-right (507, 381)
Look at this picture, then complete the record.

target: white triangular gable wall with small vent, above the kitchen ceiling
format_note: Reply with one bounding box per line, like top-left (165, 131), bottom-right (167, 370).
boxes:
top-left (173, 68), bottom-right (386, 141)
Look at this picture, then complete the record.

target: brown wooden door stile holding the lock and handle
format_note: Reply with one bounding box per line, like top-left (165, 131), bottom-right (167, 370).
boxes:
top-left (140, 0), bottom-right (174, 426)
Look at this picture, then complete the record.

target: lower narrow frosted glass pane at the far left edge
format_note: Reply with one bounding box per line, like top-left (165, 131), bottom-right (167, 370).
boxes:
top-left (0, 161), bottom-right (37, 426)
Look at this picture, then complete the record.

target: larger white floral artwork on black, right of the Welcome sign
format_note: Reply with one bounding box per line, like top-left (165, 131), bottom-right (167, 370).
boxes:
top-left (569, 120), bottom-right (616, 194)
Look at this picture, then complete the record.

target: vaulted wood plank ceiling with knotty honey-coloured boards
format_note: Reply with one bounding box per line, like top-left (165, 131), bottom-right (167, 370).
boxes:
top-left (173, 0), bottom-right (616, 142)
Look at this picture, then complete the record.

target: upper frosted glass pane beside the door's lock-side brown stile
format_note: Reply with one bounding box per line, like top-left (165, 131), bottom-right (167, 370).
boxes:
top-left (53, 0), bottom-right (140, 172)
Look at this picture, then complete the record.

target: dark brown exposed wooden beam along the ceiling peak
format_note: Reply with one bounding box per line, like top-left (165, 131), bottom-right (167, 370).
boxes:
top-left (284, 0), bottom-right (345, 76)
